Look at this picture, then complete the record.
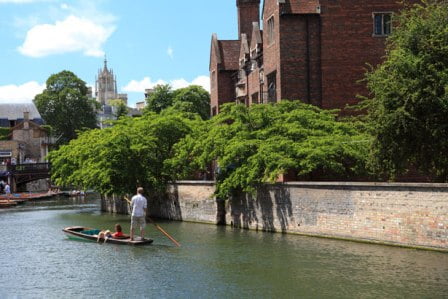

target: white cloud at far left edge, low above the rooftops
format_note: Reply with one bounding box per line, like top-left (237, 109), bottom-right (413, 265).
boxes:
top-left (0, 81), bottom-right (45, 103)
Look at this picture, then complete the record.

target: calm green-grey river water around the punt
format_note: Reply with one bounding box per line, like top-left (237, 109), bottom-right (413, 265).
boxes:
top-left (0, 197), bottom-right (448, 298)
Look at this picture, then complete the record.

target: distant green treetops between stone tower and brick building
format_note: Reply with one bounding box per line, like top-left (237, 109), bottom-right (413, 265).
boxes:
top-left (145, 85), bottom-right (210, 119)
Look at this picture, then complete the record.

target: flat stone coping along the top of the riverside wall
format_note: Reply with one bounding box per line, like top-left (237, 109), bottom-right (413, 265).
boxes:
top-left (175, 180), bottom-right (448, 189)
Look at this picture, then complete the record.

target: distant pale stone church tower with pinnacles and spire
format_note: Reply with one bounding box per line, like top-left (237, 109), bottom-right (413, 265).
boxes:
top-left (95, 57), bottom-right (118, 105)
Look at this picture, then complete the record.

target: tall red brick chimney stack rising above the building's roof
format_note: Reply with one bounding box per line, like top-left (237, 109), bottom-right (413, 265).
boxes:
top-left (236, 0), bottom-right (260, 42)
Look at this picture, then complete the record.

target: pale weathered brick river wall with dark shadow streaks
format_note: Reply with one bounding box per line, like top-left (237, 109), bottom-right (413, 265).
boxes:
top-left (102, 181), bottom-right (448, 252)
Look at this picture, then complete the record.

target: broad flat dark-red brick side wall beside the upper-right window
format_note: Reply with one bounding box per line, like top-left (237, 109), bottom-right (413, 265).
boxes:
top-left (320, 0), bottom-right (418, 108)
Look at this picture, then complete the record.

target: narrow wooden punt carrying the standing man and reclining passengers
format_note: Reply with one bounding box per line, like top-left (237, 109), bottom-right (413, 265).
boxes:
top-left (62, 226), bottom-right (153, 245)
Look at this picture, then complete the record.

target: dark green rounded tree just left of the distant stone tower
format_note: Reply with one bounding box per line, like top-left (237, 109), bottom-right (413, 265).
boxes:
top-left (34, 71), bottom-right (96, 144)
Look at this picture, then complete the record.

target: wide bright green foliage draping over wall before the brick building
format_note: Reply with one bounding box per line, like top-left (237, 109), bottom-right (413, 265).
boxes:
top-left (166, 101), bottom-right (370, 198)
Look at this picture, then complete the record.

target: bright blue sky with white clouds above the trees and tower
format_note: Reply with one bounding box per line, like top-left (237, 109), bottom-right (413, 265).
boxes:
top-left (0, 0), bottom-right (238, 107)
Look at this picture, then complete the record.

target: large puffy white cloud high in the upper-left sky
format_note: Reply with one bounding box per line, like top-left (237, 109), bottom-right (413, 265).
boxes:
top-left (17, 14), bottom-right (115, 57)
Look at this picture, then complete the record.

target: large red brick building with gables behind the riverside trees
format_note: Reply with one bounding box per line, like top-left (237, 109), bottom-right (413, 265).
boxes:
top-left (210, 0), bottom-right (416, 115)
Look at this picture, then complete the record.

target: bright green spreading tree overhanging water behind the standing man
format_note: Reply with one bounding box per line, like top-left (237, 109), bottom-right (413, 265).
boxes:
top-left (49, 112), bottom-right (198, 194)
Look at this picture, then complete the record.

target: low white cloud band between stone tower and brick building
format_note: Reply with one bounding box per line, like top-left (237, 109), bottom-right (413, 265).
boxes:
top-left (122, 76), bottom-right (210, 93)
